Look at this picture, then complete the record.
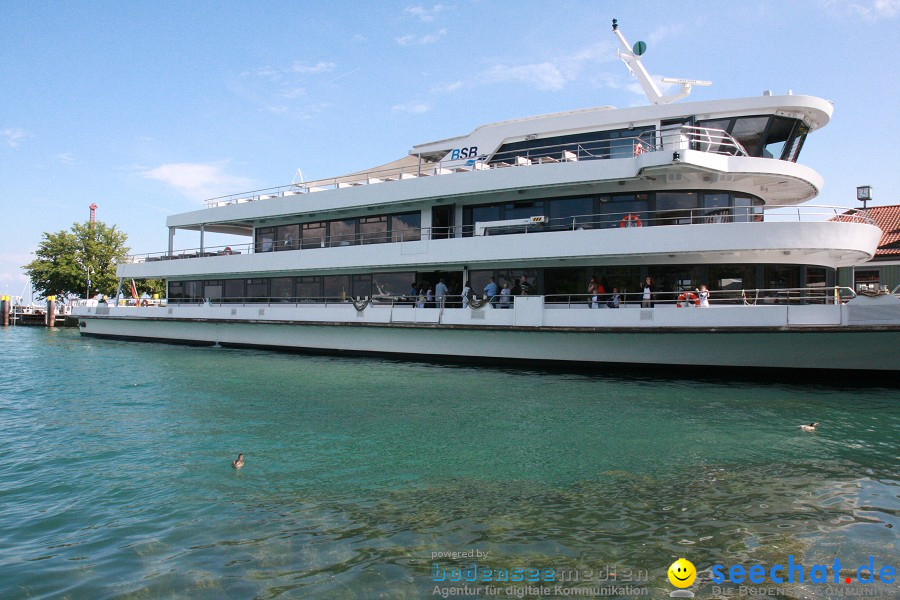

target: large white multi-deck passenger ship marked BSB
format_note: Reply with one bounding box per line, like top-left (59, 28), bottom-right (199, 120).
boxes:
top-left (76, 21), bottom-right (900, 375)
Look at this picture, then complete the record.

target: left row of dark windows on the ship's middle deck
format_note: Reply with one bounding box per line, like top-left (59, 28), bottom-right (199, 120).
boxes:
top-left (256, 211), bottom-right (422, 252)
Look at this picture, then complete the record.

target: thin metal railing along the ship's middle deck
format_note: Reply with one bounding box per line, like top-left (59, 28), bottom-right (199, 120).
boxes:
top-left (124, 205), bottom-right (874, 263)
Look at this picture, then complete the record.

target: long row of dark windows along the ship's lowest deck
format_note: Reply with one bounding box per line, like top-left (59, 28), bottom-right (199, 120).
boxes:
top-left (168, 264), bottom-right (834, 302)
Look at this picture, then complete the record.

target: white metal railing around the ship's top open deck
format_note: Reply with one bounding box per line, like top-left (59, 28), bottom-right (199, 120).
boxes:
top-left (200, 125), bottom-right (748, 208)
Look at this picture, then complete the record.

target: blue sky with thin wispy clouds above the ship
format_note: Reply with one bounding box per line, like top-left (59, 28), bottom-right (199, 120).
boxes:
top-left (0, 0), bottom-right (900, 295)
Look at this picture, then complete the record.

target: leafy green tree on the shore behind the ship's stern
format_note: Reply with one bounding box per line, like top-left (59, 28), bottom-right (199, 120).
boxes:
top-left (23, 222), bottom-right (128, 296)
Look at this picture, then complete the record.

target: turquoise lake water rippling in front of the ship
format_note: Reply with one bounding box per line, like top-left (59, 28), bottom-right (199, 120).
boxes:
top-left (0, 327), bottom-right (900, 598)
